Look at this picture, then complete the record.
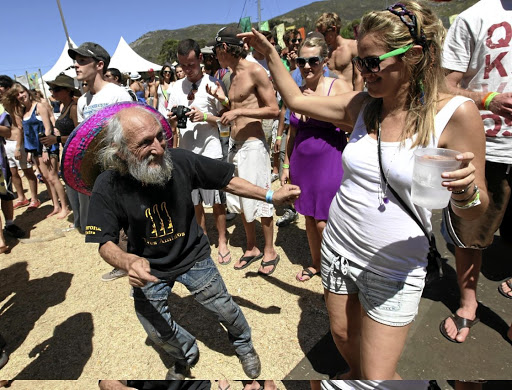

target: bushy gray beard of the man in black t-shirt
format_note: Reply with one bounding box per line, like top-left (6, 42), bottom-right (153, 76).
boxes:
top-left (127, 151), bottom-right (173, 187)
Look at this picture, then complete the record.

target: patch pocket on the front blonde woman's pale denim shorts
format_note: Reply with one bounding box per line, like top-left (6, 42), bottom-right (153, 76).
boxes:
top-left (365, 272), bottom-right (404, 311)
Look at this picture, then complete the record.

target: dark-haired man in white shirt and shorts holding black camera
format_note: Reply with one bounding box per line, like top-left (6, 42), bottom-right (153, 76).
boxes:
top-left (168, 39), bottom-right (231, 265)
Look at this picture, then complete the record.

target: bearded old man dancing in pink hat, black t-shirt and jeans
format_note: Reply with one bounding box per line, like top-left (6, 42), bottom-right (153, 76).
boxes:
top-left (78, 103), bottom-right (300, 379)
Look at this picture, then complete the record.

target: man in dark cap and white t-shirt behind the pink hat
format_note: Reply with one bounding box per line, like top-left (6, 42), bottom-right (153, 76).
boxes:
top-left (68, 42), bottom-right (132, 281)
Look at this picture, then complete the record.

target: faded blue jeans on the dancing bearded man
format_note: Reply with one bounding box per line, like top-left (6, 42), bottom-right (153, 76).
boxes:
top-left (133, 257), bottom-right (252, 364)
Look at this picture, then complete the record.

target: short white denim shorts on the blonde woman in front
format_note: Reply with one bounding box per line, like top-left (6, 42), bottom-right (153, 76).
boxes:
top-left (321, 243), bottom-right (425, 326)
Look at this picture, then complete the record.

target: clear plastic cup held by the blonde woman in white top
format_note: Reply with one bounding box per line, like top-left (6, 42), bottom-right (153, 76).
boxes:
top-left (411, 148), bottom-right (461, 209)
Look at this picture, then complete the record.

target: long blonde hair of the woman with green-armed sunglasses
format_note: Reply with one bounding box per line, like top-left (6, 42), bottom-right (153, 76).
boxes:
top-left (359, 0), bottom-right (447, 146)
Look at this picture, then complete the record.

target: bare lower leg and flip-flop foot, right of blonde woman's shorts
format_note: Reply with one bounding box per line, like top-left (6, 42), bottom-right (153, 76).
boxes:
top-left (444, 247), bottom-right (482, 342)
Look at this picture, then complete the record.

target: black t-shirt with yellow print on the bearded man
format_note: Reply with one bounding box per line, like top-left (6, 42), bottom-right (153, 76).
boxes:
top-left (85, 149), bottom-right (235, 279)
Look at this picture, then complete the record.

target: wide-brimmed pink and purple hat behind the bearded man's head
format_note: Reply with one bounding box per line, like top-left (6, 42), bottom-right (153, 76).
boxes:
top-left (62, 102), bottom-right (172, 195)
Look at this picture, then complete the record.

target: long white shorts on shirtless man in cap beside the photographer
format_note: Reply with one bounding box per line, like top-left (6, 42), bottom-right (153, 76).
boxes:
top-left (226, 138), bottom-right (274, 222)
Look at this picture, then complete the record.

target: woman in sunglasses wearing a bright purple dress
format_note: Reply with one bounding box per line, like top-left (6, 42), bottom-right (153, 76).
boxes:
top-left (281, 37), bottom-right (351, 282)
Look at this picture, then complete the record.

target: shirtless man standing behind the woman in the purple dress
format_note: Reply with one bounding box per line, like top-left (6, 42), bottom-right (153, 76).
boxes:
top-left (316, 12), bottom-right (363, 91)
